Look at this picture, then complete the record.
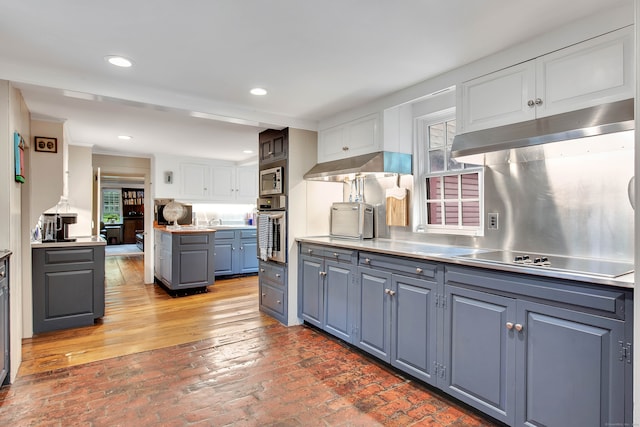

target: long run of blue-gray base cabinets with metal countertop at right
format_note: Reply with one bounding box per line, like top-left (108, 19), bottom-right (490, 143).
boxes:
top-left (297, 236), bottom-right (634, 427)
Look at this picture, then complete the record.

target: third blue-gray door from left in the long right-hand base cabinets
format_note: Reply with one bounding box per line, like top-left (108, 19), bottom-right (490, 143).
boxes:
top-left (356, 267), bottom-right (392, 362)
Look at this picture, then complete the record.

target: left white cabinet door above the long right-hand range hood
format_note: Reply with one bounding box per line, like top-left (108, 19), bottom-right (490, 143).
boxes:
top-left (457, 62), bottom-right (536, 133)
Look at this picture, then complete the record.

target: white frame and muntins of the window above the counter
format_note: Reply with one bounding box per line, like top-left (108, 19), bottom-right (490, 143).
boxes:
top-left (414, 108), bottom-right (485, 236)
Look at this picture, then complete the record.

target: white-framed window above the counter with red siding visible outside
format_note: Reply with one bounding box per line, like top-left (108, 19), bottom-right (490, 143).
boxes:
top-left (418, 115), bottom-right (482, 234)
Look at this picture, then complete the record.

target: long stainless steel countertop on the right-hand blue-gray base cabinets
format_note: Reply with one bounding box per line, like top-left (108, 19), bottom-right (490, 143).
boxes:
top-left (296, 236), bottom-right (635, 289)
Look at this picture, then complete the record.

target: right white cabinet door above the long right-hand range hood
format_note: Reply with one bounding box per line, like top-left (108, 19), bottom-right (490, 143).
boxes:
top-left (536, 28), bottom-right (634, 117)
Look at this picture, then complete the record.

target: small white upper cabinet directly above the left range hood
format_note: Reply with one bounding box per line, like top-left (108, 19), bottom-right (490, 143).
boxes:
top-left (318, 113), bottom-right (381, 163)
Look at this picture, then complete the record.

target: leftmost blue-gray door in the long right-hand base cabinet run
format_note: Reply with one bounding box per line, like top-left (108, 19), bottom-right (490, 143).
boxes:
top-left (300, 255), bottom-right (324, 328)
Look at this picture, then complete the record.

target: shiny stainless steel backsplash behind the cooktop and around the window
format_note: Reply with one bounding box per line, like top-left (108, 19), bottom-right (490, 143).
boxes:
top-left (344, 133), bottom-right (634, 262)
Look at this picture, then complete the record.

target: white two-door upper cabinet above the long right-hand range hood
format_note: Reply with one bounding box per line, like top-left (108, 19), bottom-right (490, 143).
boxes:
top-left (457, 28), bottom-right (634, 133)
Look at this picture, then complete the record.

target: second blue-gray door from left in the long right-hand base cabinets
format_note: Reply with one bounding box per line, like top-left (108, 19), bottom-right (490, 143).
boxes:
top-left (324, 260), bottom-right (353, 343)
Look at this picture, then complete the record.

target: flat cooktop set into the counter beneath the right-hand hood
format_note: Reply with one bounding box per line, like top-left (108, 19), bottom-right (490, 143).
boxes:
top-left (460, 251), bottom-right (633, 278)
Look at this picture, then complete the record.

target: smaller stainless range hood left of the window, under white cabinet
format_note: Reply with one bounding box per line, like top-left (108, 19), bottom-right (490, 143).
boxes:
top-left (304, 151), bottom-right (411, 182)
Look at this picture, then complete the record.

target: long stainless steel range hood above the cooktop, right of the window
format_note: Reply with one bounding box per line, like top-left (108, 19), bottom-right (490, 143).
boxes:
top-left (451, 99), bottom-right (634, 161)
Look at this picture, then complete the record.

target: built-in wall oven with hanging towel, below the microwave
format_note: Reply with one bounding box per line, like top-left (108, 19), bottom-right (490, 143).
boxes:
top-left (256, 210), bottom-right (287, 264)
